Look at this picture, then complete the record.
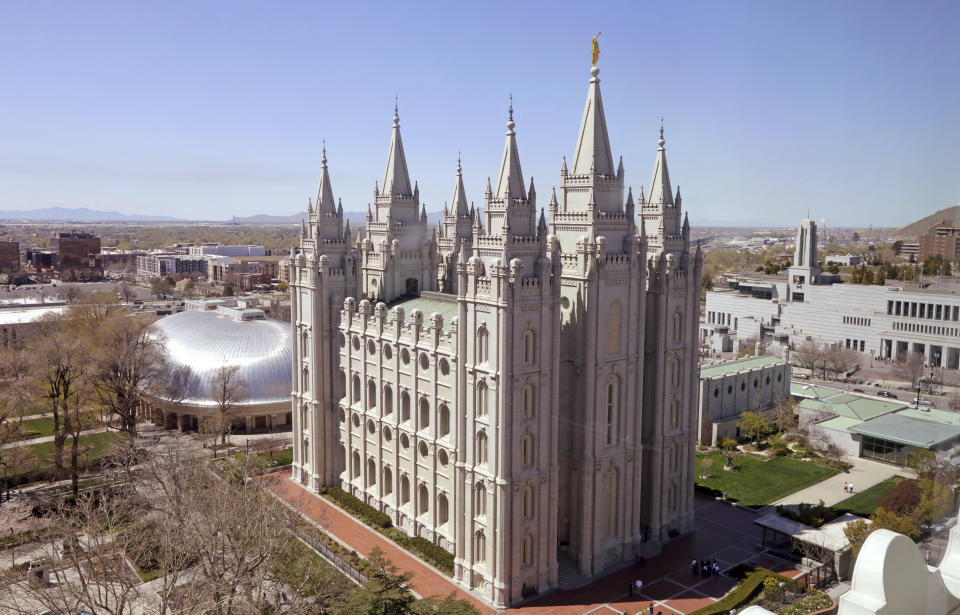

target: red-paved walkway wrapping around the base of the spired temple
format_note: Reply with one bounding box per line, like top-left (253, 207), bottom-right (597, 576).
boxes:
top-left (263, 472), bottom-right (802, 615)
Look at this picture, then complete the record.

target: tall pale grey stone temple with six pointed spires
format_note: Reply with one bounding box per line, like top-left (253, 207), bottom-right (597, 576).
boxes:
top-left (290, 61), bottom-right (701, 607)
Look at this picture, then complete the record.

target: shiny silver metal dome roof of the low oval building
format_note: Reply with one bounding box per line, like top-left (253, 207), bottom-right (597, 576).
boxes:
top-left (154, 310), bottom-right (293, 406)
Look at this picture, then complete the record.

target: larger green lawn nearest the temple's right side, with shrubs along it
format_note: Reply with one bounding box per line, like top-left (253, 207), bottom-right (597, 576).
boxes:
top-left (697, 453), bottom-right (838, 507)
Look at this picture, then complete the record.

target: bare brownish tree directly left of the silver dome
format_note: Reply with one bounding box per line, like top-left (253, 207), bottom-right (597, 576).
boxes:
top-left (93, 310), bottom-right (164, 438)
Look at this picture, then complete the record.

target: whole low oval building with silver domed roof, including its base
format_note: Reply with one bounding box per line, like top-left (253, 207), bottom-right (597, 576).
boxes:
top-left (143, 306), bottom-right (292, 433)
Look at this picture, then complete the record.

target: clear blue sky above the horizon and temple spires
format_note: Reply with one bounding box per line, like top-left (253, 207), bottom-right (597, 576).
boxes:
top-left (0, 0), bottom-right (960, 225)
